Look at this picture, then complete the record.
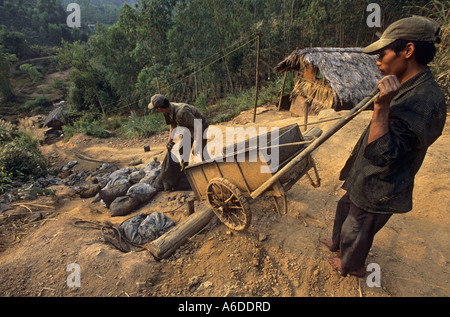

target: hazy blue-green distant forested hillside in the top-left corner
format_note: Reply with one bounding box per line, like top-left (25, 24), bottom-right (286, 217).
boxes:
top-left (0, 0), bottom-right (130, 50)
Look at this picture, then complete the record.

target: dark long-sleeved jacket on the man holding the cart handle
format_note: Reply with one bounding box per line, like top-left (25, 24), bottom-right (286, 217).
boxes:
top-left (340, 68), bottom-right (446, 213)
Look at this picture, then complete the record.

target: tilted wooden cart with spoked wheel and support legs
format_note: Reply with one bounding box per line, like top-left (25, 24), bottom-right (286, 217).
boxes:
top-left (185, 124), bottom-right (322, 230)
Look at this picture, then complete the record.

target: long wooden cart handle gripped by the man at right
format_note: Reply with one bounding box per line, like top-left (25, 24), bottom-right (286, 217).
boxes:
top-left (250, 88), bottom-right (379, 199)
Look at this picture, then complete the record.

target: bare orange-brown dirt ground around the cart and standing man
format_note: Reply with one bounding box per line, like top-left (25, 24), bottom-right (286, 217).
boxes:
top-left (0, 108), bottom-right (450, 297)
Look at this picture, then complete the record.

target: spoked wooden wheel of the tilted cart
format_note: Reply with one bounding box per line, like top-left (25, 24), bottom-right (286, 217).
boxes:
top-left (206, 177), bottom-right (252, 231)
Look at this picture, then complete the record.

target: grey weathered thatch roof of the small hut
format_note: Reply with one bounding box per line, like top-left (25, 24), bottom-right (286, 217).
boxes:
top-left (275, 48), bottom-right (382, 104)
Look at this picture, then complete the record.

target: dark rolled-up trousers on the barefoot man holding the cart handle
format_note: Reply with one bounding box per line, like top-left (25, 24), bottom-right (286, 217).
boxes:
top-left (331, 193), bottom-right (392, 276)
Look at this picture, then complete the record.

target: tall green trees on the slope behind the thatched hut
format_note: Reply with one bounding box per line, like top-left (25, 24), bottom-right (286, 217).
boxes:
top-left (53, 0), bottom-right (448, 117)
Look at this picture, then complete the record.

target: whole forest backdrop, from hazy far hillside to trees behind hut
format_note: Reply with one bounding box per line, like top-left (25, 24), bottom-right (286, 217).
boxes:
top-left (0, 0), bottom-right (449, 116)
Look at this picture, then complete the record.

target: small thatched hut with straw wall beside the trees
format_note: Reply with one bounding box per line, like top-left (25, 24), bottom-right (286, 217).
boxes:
top-left (275, 48), bottom-right (381, 114)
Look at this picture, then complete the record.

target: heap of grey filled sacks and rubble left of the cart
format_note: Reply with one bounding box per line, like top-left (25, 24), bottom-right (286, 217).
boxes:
top-left (0, 154), bottom-right (181, 217)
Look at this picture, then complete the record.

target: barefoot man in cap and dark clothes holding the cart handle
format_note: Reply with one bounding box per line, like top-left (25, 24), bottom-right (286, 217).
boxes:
top-left (320, 16), bottom-right (446, 276)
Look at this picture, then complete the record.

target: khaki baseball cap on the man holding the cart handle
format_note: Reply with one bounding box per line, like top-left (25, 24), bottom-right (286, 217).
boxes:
top-left (362, 15), bottom-right (440, 55)
